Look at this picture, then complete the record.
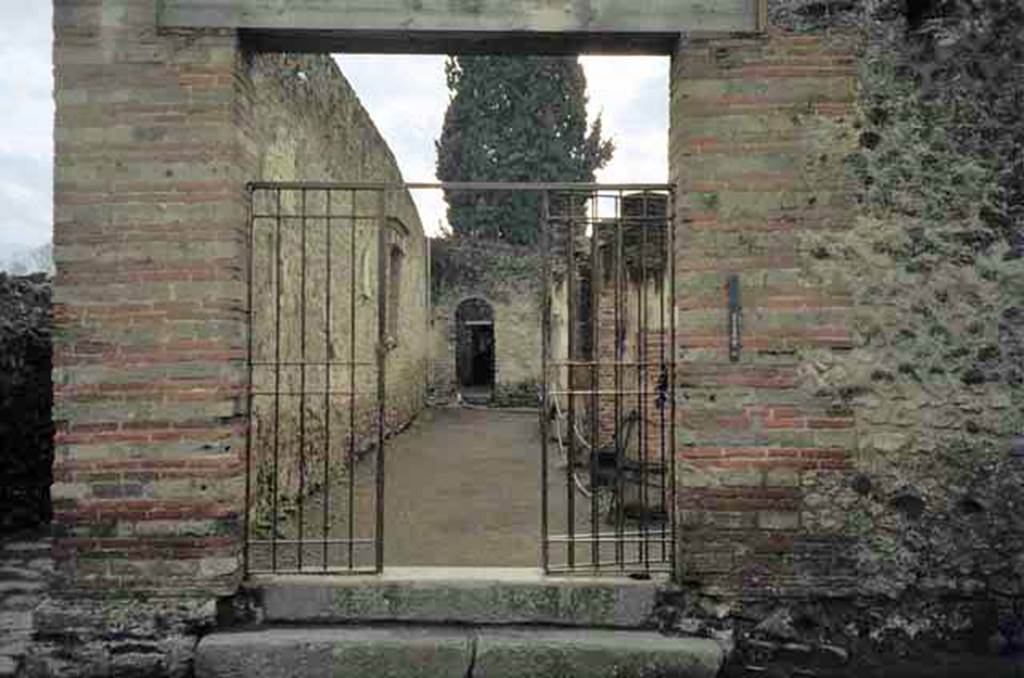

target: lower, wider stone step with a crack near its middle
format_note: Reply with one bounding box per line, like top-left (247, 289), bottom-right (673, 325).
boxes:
top-left (195, 627), bottom-right (726, 678)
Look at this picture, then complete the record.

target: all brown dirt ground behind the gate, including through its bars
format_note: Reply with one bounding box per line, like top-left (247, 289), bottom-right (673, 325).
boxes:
top-left (251, 408), bottom-right (669, 571)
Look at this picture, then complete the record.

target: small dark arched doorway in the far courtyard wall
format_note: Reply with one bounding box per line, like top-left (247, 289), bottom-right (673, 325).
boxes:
top-left (455, 299), bottom-right (495, 400)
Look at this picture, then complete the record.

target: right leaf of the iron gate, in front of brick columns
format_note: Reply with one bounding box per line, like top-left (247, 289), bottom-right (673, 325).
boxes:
top-left (542, 185), bottom-right (676, 575)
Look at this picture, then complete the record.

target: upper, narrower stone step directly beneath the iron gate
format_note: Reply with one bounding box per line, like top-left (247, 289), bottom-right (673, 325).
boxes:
top-left (250, 569), bottom-right (662, 629)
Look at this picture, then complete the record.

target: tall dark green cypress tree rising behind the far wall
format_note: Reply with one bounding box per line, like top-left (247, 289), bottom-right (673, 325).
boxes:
top-left (437, 56), bottom-right (614, 244)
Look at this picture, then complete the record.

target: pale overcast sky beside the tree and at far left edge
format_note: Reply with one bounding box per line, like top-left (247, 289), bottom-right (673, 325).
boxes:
top-left (0, 0), bottom-right (669, 249)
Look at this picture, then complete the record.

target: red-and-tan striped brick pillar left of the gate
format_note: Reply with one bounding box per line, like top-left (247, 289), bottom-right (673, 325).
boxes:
top-left (53, 0), bottom-right (247, 592)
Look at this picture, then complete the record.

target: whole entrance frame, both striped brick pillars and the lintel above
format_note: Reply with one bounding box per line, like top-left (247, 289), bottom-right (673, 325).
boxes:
top-left (53, 0), bottom-right (855, 592)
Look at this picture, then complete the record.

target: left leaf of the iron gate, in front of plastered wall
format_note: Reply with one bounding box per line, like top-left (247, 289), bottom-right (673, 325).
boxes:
top-left (245, 183), bottom-right (389, 574)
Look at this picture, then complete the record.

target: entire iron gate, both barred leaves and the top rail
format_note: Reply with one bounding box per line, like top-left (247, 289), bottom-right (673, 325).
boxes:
top-left (245, 182), bottom-right (676, 575)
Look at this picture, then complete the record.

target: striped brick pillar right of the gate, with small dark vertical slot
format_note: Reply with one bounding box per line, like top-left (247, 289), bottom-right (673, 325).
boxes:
top-left (670, 35), bottom-right (856, 593)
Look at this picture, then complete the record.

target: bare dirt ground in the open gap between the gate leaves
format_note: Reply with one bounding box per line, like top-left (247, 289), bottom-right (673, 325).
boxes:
top-left (384, 410), bottom-right (541, 567)
